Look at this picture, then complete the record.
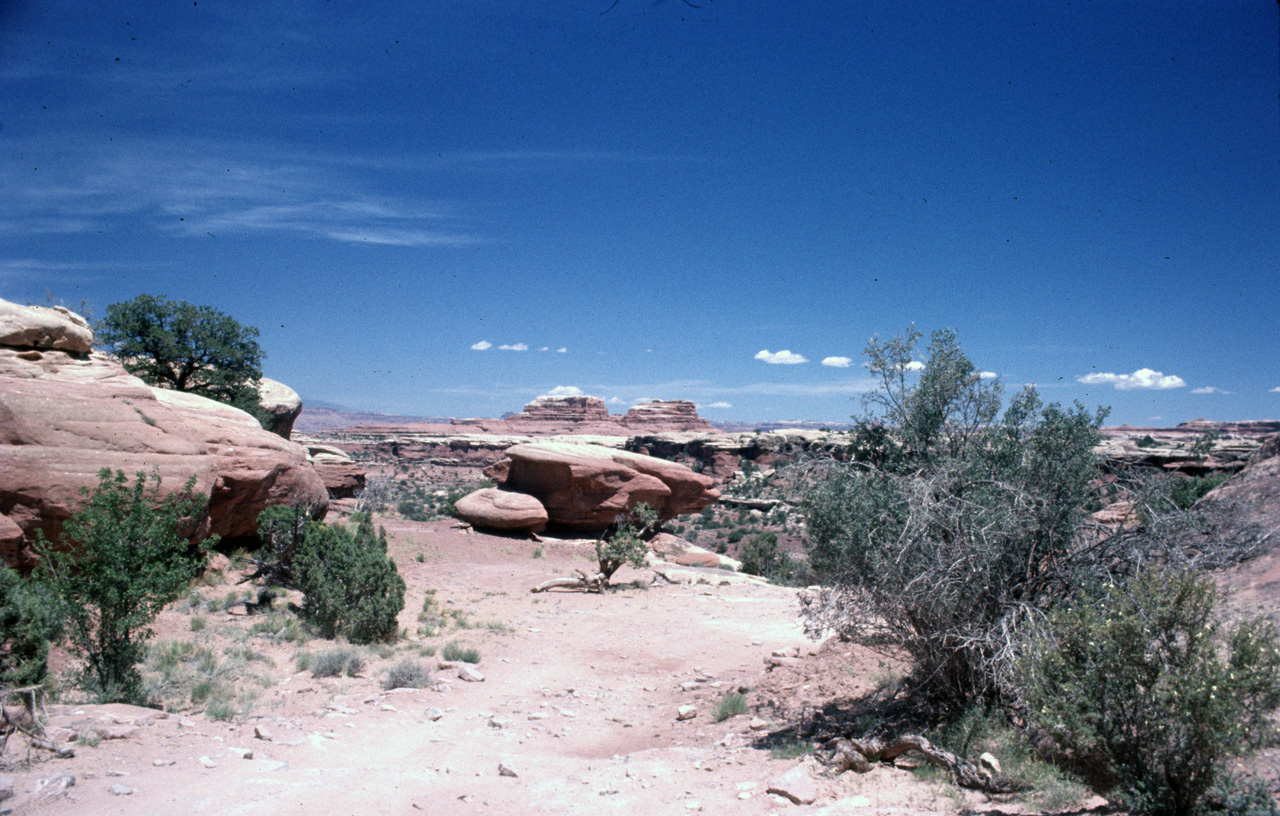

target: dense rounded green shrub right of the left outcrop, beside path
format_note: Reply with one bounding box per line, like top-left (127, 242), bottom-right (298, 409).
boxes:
top-left (292, 517), bottom-right (404, 643)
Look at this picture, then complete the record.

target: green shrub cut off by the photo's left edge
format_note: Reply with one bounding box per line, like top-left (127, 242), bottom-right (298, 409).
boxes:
top-left (0, 563), bottom-right (61, 688)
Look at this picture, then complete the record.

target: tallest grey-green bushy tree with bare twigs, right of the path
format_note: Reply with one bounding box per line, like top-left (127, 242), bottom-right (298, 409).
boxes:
top-left (804, 327), bottom-right (1106, 710)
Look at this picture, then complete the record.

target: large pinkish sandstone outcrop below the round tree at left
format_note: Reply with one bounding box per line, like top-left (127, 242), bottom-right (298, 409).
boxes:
top-left (0, 296), bottom-right (328, 567)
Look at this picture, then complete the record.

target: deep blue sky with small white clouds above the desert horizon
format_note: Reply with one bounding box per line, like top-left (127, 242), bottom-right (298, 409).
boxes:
top-left (0, 0), bottom-right (1280, 425)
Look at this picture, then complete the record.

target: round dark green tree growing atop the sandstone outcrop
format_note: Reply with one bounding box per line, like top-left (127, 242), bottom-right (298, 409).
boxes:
top-left (97, 294), bottom-right (265, 418)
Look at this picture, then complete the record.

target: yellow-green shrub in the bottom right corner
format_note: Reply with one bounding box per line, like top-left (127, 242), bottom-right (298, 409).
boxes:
top-left (1021, 569), bottom-right (1280, 816)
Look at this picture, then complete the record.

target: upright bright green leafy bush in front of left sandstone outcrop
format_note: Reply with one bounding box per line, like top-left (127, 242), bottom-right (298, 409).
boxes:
top-left (37, 468), bottom-right (207, 703)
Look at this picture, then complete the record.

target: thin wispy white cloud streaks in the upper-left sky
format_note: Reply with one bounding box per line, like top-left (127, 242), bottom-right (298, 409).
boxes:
top-left (0, 138), bottom-right (484, 248)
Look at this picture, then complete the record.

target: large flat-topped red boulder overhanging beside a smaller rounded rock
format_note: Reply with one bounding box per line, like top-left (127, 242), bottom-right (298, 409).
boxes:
top-left (485, 443), bottom-right (719, 531)
